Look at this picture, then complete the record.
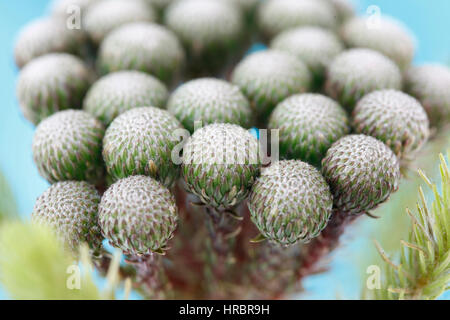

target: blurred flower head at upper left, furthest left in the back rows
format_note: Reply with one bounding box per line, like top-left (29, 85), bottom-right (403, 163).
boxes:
top-left (14, 17), bottom-right (87, 68)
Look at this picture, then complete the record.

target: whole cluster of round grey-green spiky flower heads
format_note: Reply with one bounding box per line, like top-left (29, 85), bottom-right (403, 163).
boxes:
top-left (15, 0), bottom-right (450, 255)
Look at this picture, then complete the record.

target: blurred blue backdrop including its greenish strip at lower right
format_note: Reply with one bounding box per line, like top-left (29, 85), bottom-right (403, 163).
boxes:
top-left (0, 0), bottom-right (450, 299)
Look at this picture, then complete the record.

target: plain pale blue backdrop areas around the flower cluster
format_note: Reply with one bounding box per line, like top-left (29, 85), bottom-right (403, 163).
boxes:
top-left (0, 0), bottom-right (450, 299)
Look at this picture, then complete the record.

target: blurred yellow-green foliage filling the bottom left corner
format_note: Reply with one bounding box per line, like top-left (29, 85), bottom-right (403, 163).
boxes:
top-left (0, 222), bottom-right (100, 300)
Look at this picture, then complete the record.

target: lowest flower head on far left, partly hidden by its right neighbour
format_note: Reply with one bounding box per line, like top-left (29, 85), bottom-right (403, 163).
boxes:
top-left (31, 181), bottom-right (103, 252)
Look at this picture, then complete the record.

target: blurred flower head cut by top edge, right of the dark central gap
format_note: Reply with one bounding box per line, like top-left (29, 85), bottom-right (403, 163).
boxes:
top-left (258, 0), bottom-right (337, 39)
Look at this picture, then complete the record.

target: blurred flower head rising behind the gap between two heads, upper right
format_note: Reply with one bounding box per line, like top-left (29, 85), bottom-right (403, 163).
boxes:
top-left (271, 27), bottom-right (344, 87)
